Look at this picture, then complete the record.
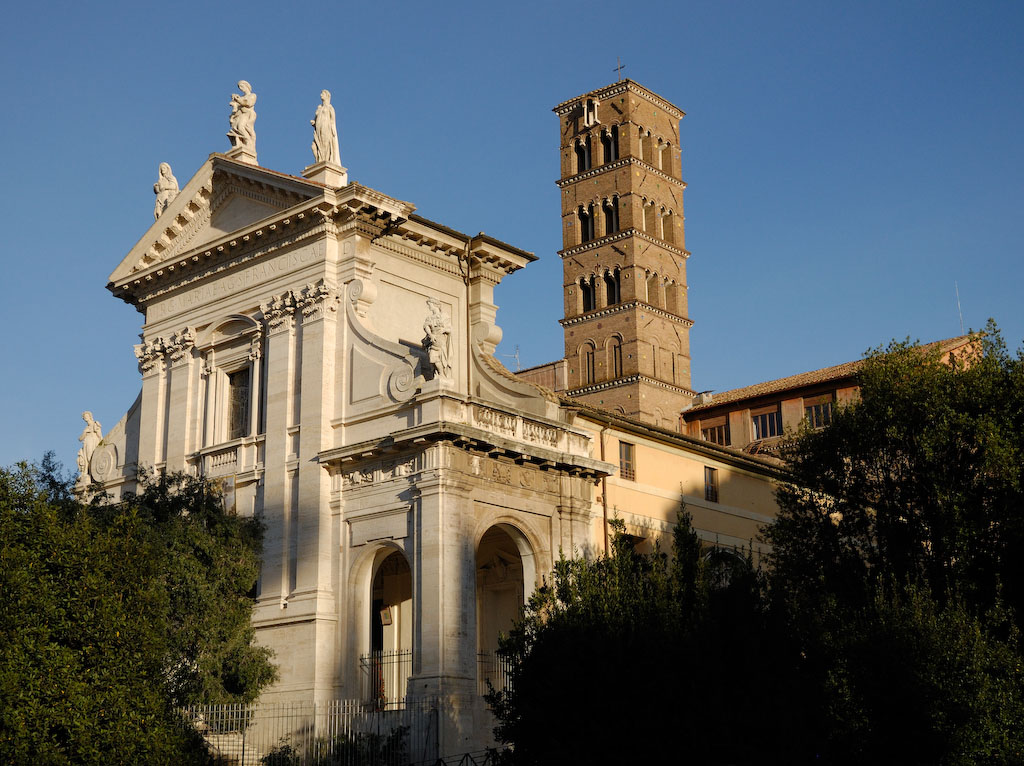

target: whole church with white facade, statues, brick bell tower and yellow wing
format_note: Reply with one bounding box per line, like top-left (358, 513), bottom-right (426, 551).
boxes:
top-left (79, 81), bottom-right (780, 755)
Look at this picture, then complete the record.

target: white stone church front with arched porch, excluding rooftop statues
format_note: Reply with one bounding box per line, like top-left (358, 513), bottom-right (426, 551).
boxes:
top-left (89, 155), bottom-right (612, 753)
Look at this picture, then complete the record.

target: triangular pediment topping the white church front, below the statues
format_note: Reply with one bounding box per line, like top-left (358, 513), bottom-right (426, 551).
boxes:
top-left (110, 155), bottom-right (323, 283)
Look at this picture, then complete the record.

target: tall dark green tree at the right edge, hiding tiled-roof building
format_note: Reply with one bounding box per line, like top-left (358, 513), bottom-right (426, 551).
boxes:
top-left (765, 325), bottom-right (1024, 764)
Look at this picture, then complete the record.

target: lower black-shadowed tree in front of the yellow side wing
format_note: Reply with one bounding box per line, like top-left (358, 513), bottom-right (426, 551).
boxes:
top-left (488, 513), bottom-right (799, 764)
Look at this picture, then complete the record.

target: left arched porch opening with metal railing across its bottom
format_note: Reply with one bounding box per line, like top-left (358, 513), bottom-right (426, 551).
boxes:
top-left (360, 551), bottom-right (413, 707)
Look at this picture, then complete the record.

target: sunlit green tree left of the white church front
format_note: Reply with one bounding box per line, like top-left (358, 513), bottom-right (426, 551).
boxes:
top-left (0, 459), bottom-right (274, 764)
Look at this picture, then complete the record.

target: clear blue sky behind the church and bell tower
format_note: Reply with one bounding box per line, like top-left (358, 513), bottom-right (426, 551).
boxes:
top-left (0, 0), bottom-right (1024, 467)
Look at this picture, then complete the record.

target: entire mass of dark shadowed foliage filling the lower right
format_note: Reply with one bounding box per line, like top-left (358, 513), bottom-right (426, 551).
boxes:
top-left (488, 325), bottom-right (1024, 766)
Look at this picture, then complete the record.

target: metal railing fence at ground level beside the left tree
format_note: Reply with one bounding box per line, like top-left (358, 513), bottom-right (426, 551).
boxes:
top-left (181, 698), bottom-right (439, 766)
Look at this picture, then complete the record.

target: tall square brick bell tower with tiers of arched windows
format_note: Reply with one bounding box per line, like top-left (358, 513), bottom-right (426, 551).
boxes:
top-left (554, 80), bottom-right (694, 430)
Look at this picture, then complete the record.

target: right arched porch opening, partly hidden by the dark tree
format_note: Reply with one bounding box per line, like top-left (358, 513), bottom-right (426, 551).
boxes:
top-left (476, 524), bottom-right (535, 694)
